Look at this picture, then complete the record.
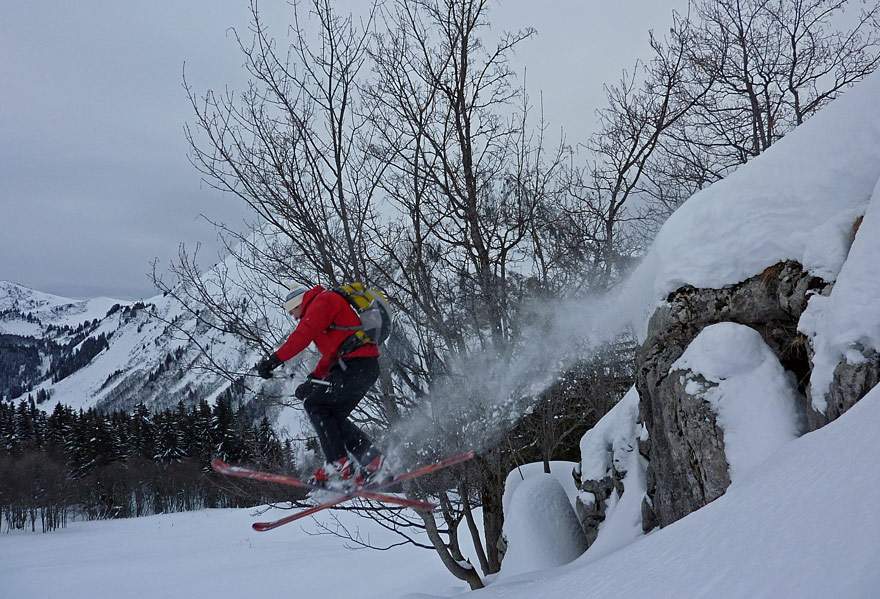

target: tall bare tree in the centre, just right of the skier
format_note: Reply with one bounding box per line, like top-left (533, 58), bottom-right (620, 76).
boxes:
top-left (360, 0), bottom-right (596, 586)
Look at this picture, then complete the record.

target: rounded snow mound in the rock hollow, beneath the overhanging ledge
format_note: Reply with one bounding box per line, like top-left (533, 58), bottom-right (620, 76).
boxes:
top-left (670, 322), bottom-right (803, 484)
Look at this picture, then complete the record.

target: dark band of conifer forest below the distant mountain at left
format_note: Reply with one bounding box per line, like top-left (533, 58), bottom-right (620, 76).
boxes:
top-left (0, 393), bottom-right (293, 532)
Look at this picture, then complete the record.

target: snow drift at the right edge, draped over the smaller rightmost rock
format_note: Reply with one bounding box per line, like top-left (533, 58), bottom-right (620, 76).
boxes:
top-left (798, 176), bottom-right (880, 413)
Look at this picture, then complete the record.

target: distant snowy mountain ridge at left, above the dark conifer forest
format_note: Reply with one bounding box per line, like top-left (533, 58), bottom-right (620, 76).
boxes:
top-left (0, 281), bottom-right (256, 411)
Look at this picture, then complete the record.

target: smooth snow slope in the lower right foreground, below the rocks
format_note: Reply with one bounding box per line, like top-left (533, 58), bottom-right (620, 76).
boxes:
top-left (450, 388), bottom-right (880, 599)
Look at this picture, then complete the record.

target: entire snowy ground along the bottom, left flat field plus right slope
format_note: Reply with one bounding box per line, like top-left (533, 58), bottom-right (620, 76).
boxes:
top-left (0, 382), bottom-right (880, 599)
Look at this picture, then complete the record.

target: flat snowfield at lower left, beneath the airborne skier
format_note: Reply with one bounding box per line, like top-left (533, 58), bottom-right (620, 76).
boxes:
top-left (0, 509), bottom-right (456, 599)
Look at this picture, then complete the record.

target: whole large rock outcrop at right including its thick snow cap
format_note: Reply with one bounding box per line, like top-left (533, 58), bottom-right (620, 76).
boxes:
top-left (622, 73), bottom-right (880, 540)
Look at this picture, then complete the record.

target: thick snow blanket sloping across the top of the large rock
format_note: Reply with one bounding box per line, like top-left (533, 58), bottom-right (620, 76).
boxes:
top-left (613, 71), bottom-right (880, 335)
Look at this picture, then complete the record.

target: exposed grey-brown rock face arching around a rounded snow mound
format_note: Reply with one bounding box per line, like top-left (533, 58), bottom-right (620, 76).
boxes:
top-left (636, 262), bottom-right (826, 530)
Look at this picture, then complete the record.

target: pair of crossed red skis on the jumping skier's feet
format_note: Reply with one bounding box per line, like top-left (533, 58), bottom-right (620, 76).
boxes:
top-left (211, 451), bottom-right (476, 532)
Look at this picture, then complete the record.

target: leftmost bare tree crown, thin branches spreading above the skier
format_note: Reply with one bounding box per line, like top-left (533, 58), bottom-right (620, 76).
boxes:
top-left (153, 0), bottom-right (398, 410)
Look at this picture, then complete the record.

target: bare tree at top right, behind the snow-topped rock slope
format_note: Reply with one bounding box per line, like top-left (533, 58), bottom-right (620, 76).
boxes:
top-left (669, 0), bottom-right (880, 183)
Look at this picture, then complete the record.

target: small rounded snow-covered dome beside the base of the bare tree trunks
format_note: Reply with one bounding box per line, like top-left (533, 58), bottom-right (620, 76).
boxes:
top-left (499, 473), bottom-right (587, 578)
